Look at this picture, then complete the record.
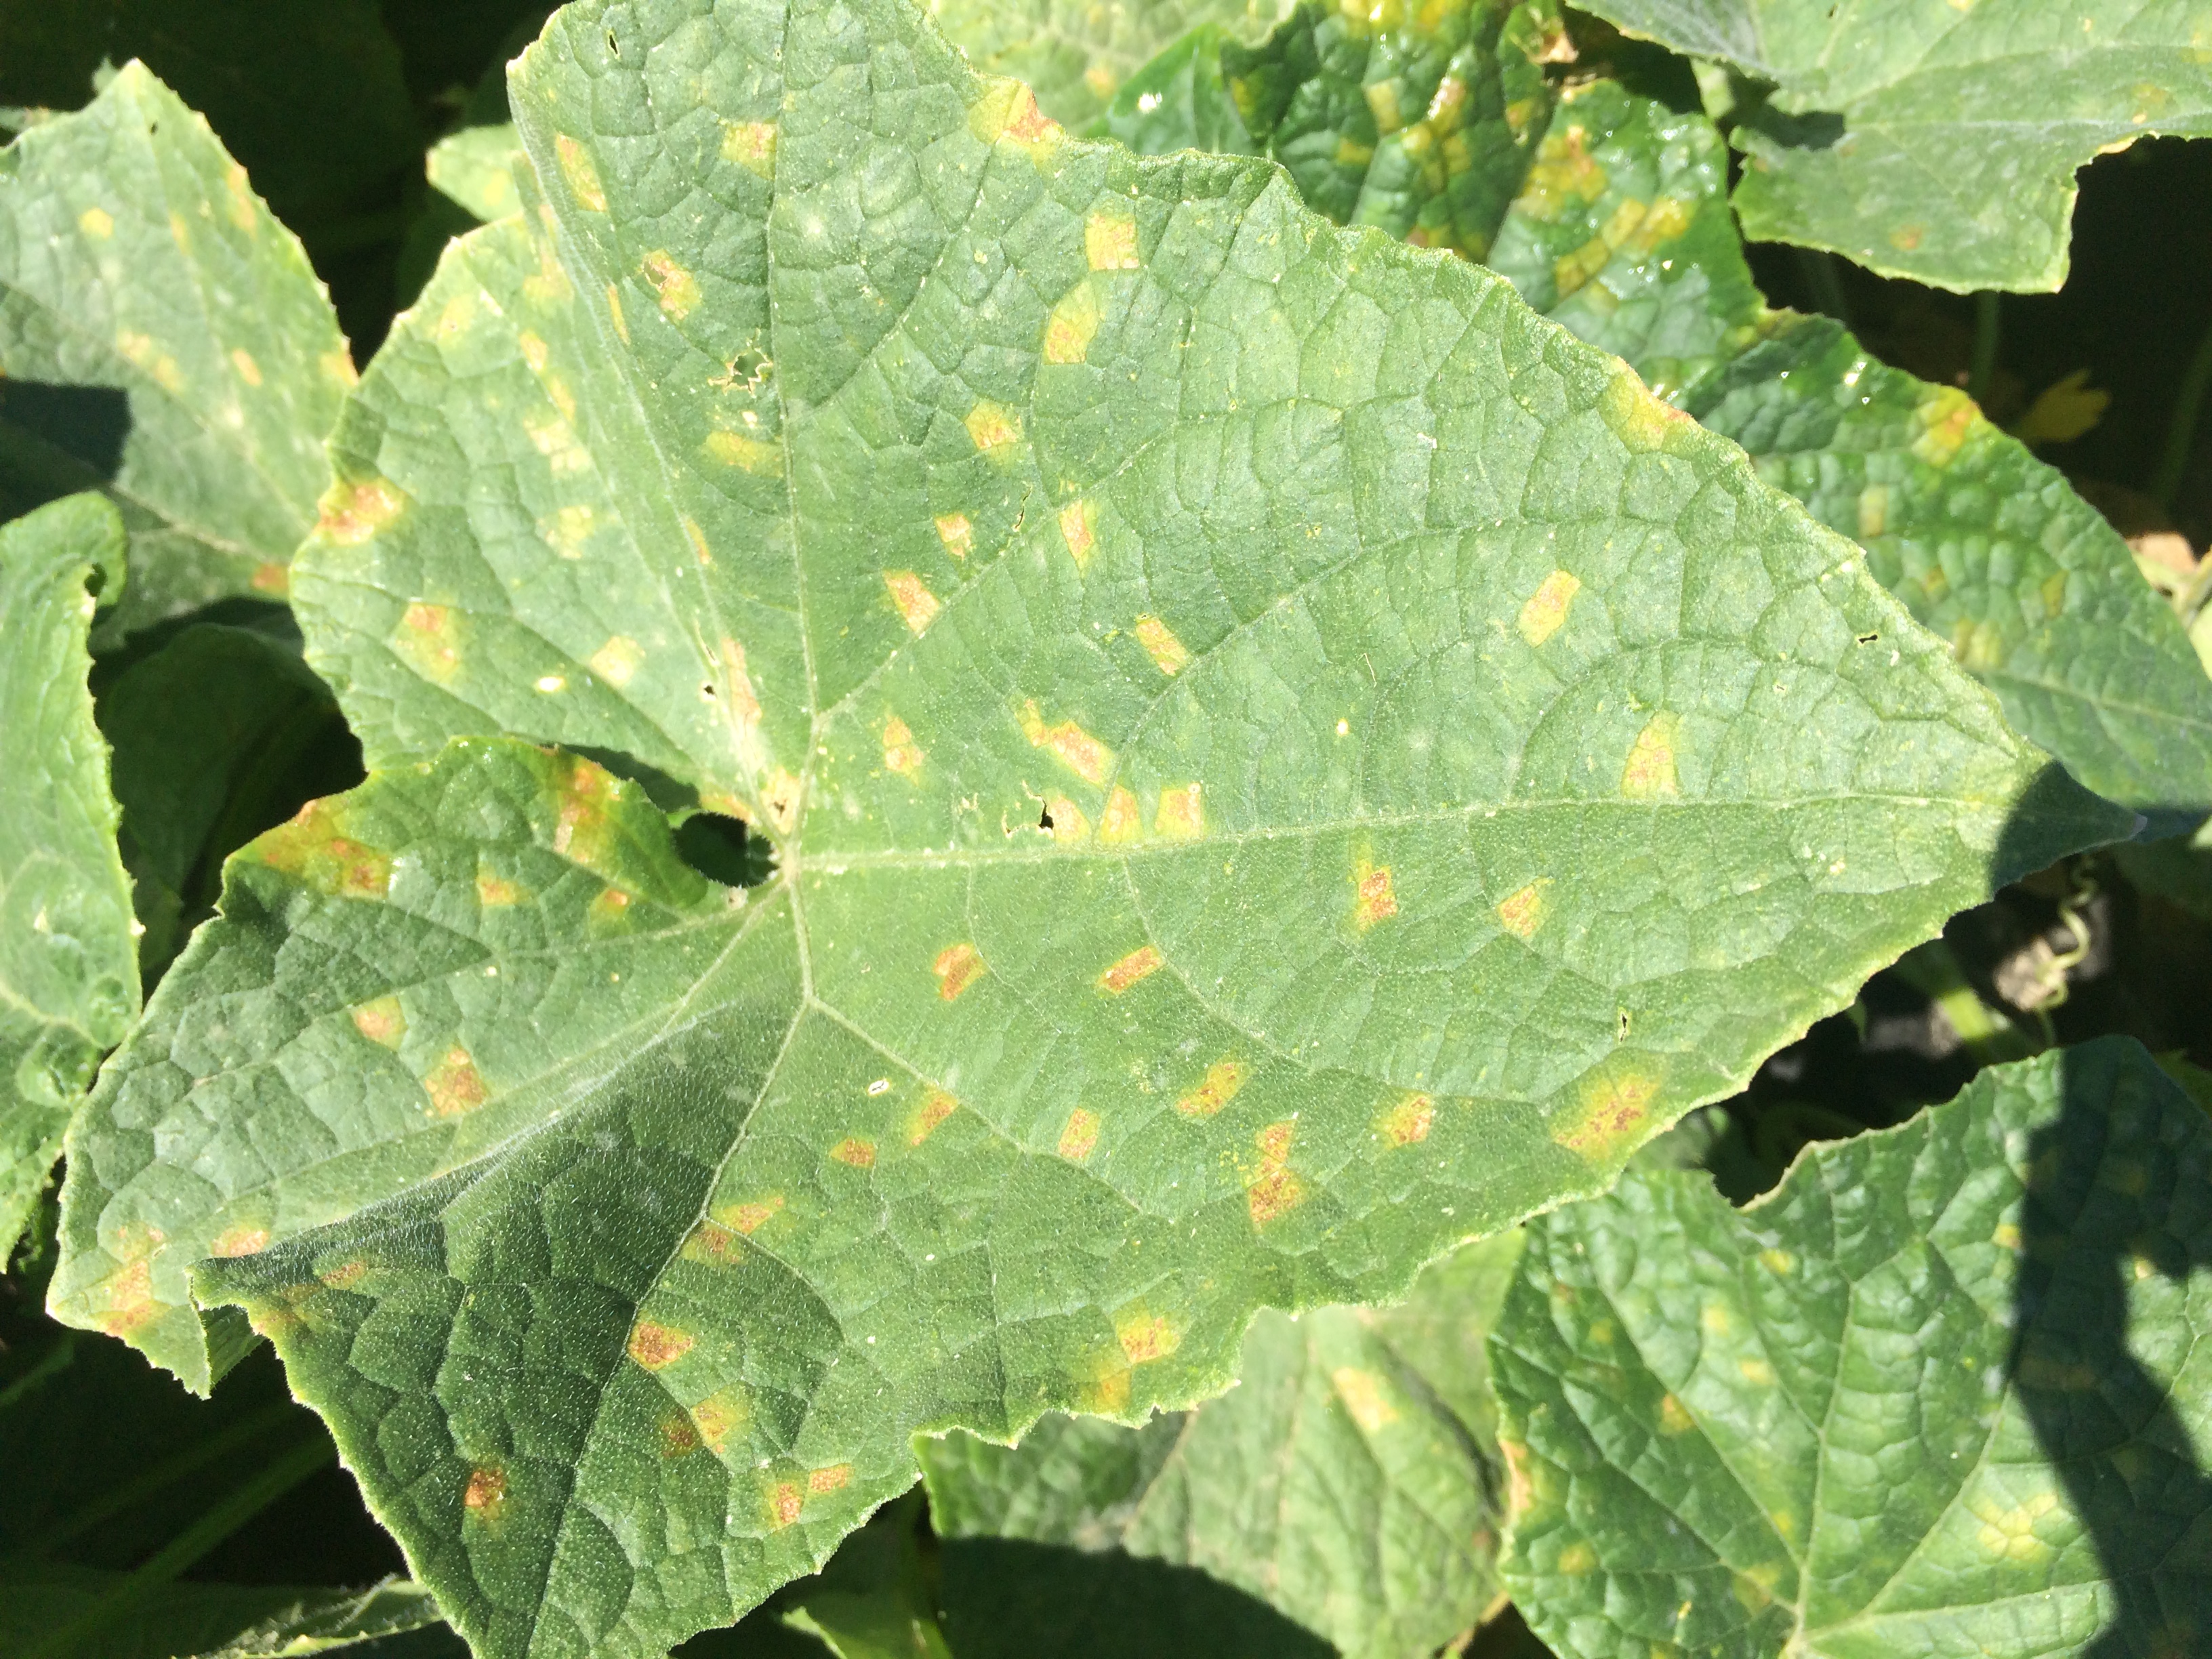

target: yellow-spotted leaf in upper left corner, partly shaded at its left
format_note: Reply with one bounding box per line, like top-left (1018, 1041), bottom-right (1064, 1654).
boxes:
top-left (0, 64), bottom-right (354, 630)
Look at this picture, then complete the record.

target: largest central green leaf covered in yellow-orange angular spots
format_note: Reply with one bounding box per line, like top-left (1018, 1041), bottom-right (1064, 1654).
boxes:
top-left (53, 0), bottom-right (2114, 1654)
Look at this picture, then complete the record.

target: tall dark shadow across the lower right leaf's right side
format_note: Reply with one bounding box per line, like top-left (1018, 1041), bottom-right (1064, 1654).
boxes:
top-left (2009, 1042), bottom-right (2212, 1659)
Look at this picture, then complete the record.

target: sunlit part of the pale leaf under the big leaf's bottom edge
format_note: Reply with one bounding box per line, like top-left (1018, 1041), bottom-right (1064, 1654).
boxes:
top-left (920, 1232), bottom-right (1522, 1659)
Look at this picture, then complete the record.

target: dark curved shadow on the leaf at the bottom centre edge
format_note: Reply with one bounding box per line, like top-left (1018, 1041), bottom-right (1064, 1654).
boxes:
top-left (938, 1537), bottom-right (1336, 1659)
